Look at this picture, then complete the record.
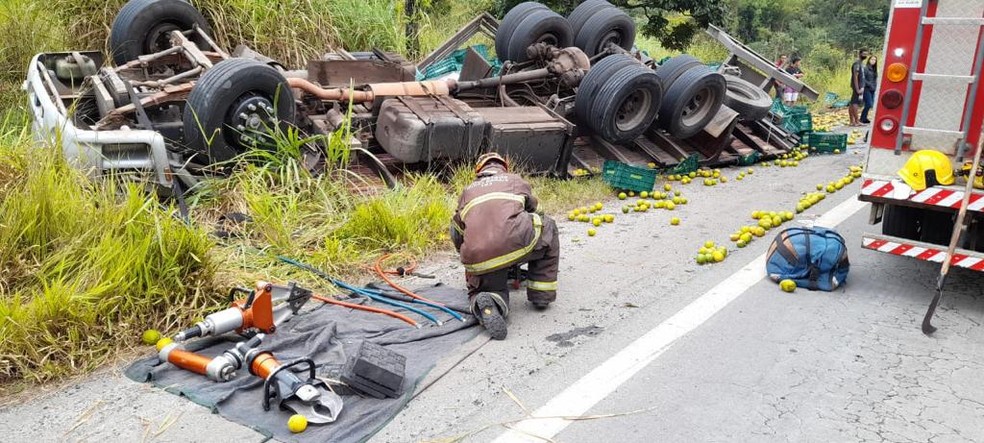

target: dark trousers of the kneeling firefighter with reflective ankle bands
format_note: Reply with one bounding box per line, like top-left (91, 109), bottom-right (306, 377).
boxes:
top-left (465, 216), bottom-right (560, 310)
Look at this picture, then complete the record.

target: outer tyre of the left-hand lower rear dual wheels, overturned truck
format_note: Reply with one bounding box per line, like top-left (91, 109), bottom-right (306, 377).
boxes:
top-left (587, 64), bottom-right (663, 143)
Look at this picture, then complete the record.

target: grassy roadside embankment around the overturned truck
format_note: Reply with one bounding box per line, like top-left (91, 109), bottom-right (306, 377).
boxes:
top-left (0, 0), bottom-right (608, 393)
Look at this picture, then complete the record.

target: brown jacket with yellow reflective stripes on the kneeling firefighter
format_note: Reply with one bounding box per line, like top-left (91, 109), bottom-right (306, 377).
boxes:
top-left (451, 168), bottom-right (543, 274)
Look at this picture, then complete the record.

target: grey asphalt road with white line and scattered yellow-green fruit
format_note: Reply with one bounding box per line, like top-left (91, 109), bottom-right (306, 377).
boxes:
top-left (0, 144), bottom-right (984, 442)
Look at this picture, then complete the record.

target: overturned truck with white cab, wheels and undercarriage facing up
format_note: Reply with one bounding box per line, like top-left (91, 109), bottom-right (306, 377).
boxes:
top-left (24, 0), bottom-right (816, 191)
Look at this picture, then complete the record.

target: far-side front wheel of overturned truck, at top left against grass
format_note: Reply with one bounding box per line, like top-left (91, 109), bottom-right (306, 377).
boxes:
top-left (109, 0), bottom-right (212, 65)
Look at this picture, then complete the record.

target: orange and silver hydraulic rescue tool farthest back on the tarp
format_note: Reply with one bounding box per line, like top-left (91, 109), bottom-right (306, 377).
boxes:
top-left (174, 281), bottom-right (311, 342)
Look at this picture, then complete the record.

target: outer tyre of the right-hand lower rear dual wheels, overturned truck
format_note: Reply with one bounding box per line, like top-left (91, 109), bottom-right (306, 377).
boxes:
top-left (659, 65), bottom-right (727, 138)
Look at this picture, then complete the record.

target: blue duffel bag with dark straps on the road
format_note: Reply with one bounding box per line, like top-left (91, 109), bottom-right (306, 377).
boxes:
top-left (765, 227), bottom-right (851, 291)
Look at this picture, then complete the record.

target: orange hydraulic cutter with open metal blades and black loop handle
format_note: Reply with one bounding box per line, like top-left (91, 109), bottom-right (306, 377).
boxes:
top-left (248, 352), bottom-right (342, 425)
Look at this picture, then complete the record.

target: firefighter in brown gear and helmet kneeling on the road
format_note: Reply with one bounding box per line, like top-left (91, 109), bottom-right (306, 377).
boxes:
top-left (451, 152), bottom-right (560, 340)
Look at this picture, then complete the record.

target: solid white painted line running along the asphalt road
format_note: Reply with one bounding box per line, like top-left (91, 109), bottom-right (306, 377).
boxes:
top-left (495, 194), bottom-right (867, 443)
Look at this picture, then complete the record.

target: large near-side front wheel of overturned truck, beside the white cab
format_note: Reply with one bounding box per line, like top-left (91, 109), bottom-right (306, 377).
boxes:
top-left (183, 58), bottom-right (295, 164)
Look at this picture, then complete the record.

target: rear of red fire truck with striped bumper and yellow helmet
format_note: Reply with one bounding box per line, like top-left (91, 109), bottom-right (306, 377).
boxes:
top-left (859, 0), bottom-right (984, 271)
